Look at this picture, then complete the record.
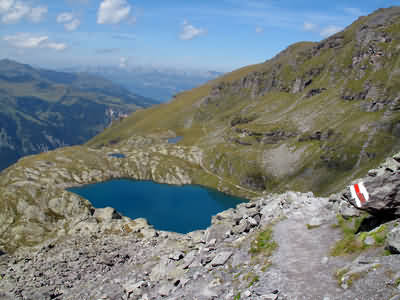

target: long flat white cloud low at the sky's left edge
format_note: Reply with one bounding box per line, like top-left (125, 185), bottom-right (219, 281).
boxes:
top-left (3, 33), bottom-right (67, 51)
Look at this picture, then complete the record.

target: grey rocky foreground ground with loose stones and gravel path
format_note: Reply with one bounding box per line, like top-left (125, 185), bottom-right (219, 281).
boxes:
top-left (0, 151), bottom-right (400, 300)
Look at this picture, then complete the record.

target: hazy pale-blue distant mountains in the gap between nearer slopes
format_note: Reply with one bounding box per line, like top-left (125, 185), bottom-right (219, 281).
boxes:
top-left (63, 66), bottom-right (223, 102)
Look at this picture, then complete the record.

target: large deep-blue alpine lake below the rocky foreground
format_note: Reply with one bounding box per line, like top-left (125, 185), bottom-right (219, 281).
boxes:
top-left (68, 179), bottom-right (247, 233)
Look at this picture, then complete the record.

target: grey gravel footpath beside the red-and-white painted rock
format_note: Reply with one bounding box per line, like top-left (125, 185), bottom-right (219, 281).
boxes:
top-left (268, 200), bottom-right (349, 300)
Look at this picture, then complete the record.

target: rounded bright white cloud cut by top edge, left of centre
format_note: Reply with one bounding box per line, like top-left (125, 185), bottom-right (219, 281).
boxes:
top-left (97, 0), bottom-right (131, 24)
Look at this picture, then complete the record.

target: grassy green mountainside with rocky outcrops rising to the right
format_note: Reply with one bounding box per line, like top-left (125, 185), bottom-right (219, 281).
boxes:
top-left (89, 7), bottom-right (400, 194)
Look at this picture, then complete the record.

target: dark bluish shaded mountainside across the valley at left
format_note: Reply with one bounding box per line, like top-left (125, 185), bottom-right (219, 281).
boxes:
top-left (0, 60), bottom-right (154, 169)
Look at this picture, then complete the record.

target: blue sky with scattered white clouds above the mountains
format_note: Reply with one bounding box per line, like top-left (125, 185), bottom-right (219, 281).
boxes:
top-left (0, 0), bottom-right (400, 72)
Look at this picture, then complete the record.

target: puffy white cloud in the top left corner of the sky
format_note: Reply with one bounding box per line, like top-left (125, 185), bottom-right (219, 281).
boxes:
top-left (0, 0), bottom-right (48, 24)
